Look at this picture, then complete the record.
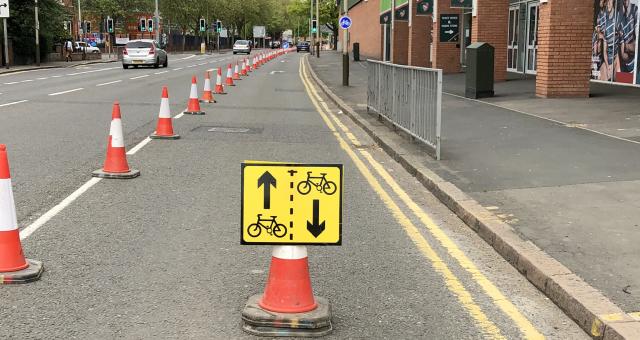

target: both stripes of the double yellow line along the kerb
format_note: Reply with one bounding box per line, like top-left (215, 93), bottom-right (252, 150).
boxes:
top-left (299, 57), bottom-right (544, 339)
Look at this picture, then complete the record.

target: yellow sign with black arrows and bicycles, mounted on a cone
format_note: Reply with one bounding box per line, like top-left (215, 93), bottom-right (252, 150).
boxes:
top-left (240, 162), bottom-right (342, 245)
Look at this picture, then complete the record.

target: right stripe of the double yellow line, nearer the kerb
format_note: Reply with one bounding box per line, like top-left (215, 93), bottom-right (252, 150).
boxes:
top-left (302, 58), bottom-right (544, 339)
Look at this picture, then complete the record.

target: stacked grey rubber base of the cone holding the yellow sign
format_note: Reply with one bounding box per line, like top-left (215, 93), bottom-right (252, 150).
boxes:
top-left (242, 294), bottom-right (333, 337)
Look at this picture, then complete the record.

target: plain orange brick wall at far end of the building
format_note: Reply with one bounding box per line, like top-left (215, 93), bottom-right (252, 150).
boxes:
top-left (338, 0), bottom-right (382, 59)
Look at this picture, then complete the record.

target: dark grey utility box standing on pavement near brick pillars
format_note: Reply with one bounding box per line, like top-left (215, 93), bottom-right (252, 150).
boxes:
top-left (464, 42), bottom-right (494, 99)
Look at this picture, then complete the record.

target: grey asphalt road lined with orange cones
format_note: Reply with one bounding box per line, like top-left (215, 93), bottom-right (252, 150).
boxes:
top-left (0, 53), bottom-right (586, 339)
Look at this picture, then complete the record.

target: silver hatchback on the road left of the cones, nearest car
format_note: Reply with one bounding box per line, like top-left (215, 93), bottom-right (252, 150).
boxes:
top-left (122, 39), bottom-right (169, 69)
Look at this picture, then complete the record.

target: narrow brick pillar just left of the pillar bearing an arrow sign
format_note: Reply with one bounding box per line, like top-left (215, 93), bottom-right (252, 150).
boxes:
top-left (408, 7), bottom-right (433, 67)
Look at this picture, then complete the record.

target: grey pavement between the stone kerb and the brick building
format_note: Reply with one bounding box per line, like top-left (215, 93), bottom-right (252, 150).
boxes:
top-left (310, 53), bottom-right (640, 330)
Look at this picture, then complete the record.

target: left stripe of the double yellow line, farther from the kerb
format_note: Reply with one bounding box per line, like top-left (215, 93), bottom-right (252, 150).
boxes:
top-left (300, 57), bottom-right (505, 339)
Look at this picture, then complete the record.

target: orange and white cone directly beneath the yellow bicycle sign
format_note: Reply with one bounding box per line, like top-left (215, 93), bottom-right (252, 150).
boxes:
top-left (242, 246), bottom-right (332, 337)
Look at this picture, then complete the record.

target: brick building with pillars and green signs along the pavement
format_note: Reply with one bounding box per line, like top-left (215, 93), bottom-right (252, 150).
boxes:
top-left (340, 0), bottom-right (640, 97)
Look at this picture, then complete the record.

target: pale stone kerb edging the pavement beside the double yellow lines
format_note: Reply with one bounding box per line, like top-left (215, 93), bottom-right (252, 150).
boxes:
top-left (304, 58), bottom-right (640, 340)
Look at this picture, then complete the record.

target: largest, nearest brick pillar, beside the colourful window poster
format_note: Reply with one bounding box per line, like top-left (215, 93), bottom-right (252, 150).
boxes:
top-left (536, 0), bottom-right (594, 97)
